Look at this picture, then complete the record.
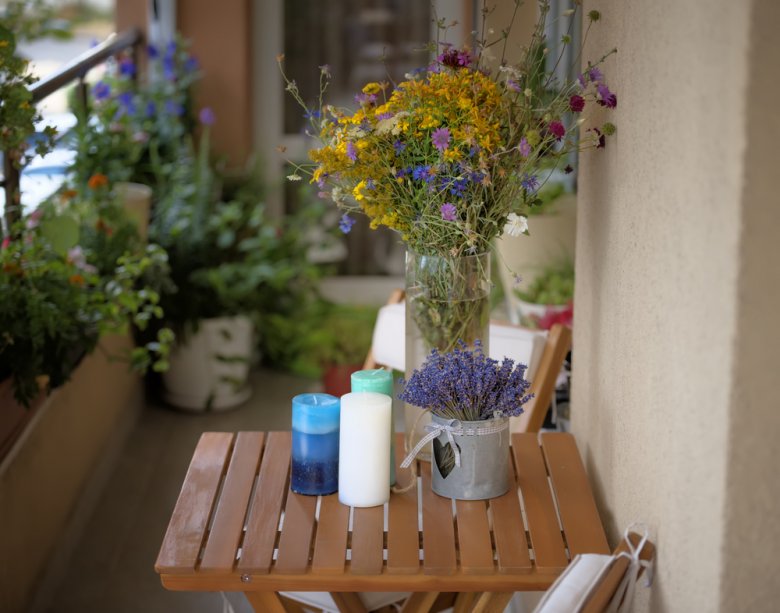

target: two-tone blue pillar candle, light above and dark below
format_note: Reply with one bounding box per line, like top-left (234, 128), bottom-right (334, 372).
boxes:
top-left (290, 394), bottom-right (341, 496)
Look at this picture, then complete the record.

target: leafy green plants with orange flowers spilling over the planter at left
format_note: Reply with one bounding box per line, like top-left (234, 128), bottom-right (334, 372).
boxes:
top-left (0, 205), bottom-right (172, 405)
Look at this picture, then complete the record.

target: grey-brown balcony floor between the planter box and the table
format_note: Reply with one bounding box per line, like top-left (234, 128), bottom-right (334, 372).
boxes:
top-left (42, 370), bottom-right (318, 613)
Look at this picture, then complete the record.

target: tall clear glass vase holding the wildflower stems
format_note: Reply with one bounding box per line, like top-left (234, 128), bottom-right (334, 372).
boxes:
top-left (404, 251), bottom-right (490, 460)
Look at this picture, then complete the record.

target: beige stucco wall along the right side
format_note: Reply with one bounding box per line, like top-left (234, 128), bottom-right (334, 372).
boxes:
top-left (572, 0), bottom-right (780, 611)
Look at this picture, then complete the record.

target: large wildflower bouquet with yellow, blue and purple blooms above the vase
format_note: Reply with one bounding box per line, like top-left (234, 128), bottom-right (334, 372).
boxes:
top-left (279, 0), bottom-right (617, 257)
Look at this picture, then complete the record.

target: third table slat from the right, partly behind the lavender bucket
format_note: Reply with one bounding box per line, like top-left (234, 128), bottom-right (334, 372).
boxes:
top-left (490, 459), bottom-right (531, 573)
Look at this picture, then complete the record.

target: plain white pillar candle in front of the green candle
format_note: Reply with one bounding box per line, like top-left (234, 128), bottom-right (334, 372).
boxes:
top-left (339, 392), bottom-right (392, 507)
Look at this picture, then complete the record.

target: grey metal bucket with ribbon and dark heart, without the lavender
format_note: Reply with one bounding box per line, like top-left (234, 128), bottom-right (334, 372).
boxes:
top-left (428, 415), bottom-right (510, 500)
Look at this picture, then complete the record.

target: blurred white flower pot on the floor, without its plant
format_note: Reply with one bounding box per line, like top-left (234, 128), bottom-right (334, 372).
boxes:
top-left (163, 316), bottom-right (254, 411)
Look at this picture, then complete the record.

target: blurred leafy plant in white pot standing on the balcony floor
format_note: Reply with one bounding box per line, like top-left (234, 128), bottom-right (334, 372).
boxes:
top-left (145, 120), bottom-right (318, 410)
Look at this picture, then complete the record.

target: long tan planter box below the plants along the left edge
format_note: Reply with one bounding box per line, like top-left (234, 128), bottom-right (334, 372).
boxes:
top-left (0, 336), bottom-right (143, 611)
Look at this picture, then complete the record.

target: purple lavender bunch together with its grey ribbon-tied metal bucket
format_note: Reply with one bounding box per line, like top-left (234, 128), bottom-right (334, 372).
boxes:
top-left (400, 342), bottom-right (532, 500)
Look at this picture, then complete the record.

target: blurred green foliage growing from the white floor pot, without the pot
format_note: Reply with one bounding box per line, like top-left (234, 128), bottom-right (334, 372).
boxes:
top-left (150, 138), bottom-right (319, 331)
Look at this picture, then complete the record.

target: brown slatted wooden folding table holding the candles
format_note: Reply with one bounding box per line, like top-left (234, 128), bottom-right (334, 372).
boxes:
top-left (155, 432), bottom-right (610, 612)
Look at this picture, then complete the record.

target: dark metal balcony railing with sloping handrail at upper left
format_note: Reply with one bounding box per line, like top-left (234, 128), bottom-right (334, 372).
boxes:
top-left (0, 28), bottom-right (143, 229)
